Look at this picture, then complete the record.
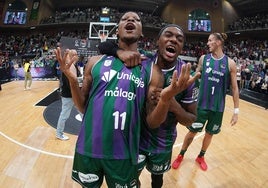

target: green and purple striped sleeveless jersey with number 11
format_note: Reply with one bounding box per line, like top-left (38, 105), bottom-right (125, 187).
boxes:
top-left (76, 56), bottom-right (153, 164)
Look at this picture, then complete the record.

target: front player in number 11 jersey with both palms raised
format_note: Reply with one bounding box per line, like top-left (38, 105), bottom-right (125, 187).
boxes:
top-left (56, 12), bottom-right (197, 187)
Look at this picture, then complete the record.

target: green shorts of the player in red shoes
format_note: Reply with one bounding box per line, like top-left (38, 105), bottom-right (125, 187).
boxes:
top-left (187, 109), bottom-right (223, 134)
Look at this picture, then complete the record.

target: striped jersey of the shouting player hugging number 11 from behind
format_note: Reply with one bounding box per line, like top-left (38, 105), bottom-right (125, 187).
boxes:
top-left (140, 59), bottom-right (198, 154)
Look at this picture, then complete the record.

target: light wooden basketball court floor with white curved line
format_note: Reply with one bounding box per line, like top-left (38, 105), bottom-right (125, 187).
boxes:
top-left (0, 81), bottom-right (268, 188)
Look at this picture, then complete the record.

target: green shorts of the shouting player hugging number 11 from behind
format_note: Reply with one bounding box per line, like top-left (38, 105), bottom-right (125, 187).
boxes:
top-left (138, 151), bottom-right (172, 174)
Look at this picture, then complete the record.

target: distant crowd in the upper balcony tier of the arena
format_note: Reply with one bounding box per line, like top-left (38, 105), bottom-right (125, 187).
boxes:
top-left (40, 8), bottom-right (268, 31)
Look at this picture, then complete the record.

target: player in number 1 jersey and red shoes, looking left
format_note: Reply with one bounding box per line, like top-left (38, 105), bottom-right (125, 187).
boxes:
top-left (172, 33), bottom-right (239, 171)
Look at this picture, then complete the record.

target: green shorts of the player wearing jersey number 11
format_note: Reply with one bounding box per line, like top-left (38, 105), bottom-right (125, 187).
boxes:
top-left (72, 152), bottom-right (139, 188)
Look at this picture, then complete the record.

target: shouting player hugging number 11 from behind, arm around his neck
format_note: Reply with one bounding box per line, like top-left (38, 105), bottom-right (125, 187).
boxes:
top-left (99, 24), bottom-right (198, 188)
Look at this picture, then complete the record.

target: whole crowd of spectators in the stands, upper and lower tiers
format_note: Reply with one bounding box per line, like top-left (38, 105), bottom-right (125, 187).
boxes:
top-left (0, 8), bottom-right (268, 93)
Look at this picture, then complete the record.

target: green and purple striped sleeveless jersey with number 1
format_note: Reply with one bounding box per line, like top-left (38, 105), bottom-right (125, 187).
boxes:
top-left (198, 54), bottom-right (230, 112)
